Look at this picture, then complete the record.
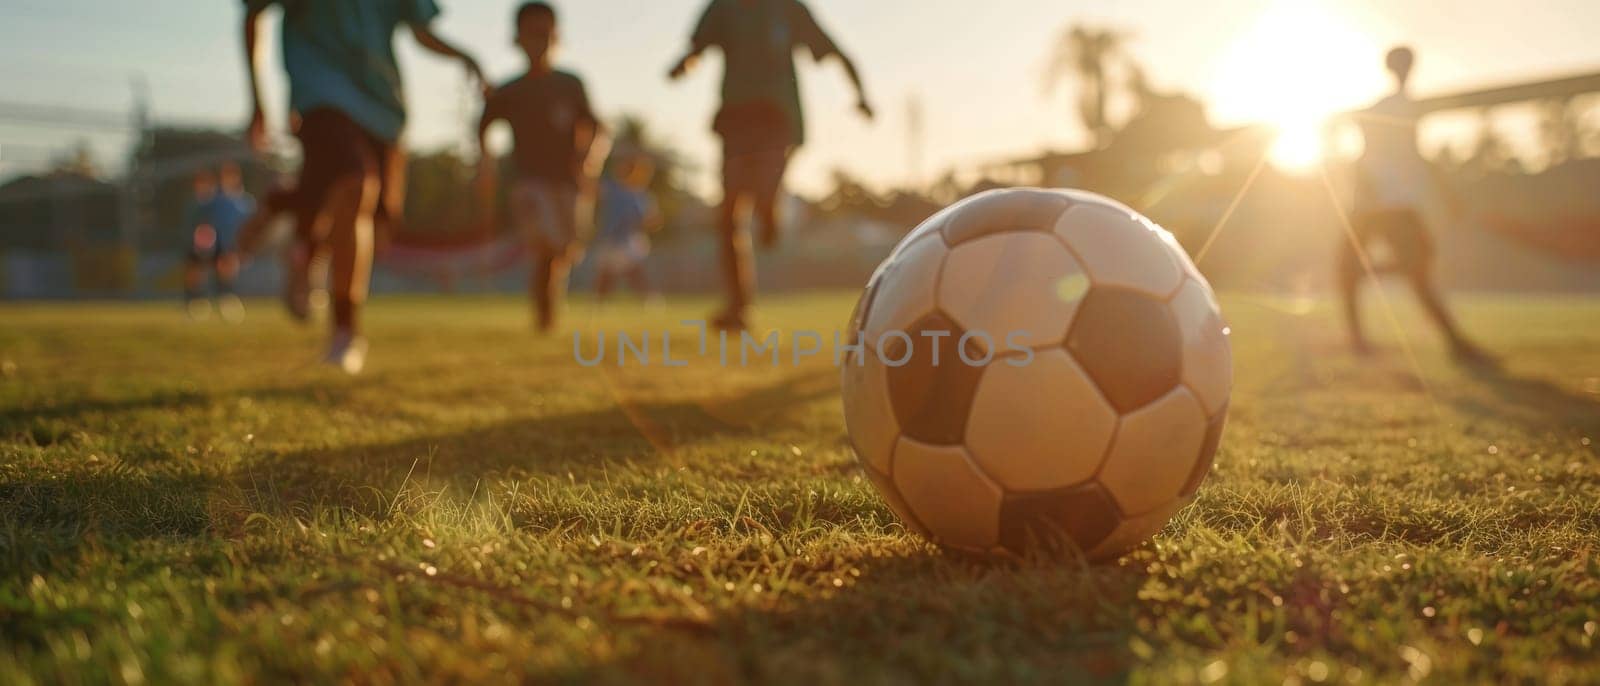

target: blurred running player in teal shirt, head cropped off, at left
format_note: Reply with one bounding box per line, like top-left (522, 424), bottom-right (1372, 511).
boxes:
top-left (245, 0), bottom-right (482, 374)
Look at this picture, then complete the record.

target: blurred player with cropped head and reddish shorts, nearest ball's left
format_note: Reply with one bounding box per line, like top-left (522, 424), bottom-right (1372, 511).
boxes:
top-left (670, 0), bottom-right (872, 329)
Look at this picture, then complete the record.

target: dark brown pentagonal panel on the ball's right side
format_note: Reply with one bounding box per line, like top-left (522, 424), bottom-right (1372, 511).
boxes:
top-left (1067, 288), bottom-right (1182, 413)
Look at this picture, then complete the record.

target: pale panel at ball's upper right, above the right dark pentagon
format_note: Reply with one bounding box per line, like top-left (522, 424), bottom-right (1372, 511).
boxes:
top-left (1056, 205), bottom-right (1184, 301)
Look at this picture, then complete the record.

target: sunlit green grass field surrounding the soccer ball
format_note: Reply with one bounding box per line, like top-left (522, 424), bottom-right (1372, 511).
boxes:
top-left (0, 294), bottom-right (1600, 683)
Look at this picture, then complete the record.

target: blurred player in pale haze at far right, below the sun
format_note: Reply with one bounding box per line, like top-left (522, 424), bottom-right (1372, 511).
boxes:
top-left (1338, 46), bottom-right (1490, 363)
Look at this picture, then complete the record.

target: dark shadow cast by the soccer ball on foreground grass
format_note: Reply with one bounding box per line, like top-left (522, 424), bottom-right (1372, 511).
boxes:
top-left (594, 553), bottom-right (1146, 683)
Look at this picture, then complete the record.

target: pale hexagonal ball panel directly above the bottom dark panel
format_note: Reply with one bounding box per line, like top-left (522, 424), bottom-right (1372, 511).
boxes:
top-left (966, 349), bottom-right (1117, 493)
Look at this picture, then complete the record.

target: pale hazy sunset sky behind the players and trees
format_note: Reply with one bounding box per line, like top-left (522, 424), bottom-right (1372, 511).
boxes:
top-left (0, 0), bottom-right (1600, 193)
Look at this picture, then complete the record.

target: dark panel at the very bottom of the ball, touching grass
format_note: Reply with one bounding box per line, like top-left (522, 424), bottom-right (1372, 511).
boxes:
top-left (1000, 481), bottom-right (1122, 555)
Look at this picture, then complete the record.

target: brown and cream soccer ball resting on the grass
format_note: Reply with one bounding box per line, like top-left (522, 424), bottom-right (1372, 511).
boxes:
top-left (843, 189), bottom-right (1232, 560)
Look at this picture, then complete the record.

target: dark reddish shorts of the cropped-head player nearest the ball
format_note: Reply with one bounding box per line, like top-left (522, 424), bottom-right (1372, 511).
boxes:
top-left (712, 102), bottom-right (792, 197)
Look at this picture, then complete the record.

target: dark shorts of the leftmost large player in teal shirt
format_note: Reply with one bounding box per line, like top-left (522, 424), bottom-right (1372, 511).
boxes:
top-left (294, 107), bottom-right (405, 239)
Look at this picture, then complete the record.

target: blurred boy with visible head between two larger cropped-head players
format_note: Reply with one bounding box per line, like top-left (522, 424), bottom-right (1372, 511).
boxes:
top-left (478, 2), bottom-right (603, 333)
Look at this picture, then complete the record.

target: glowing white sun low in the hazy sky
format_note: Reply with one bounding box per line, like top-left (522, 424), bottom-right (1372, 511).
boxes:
top-left (1211, 0), bottom-right (1381, 173)
